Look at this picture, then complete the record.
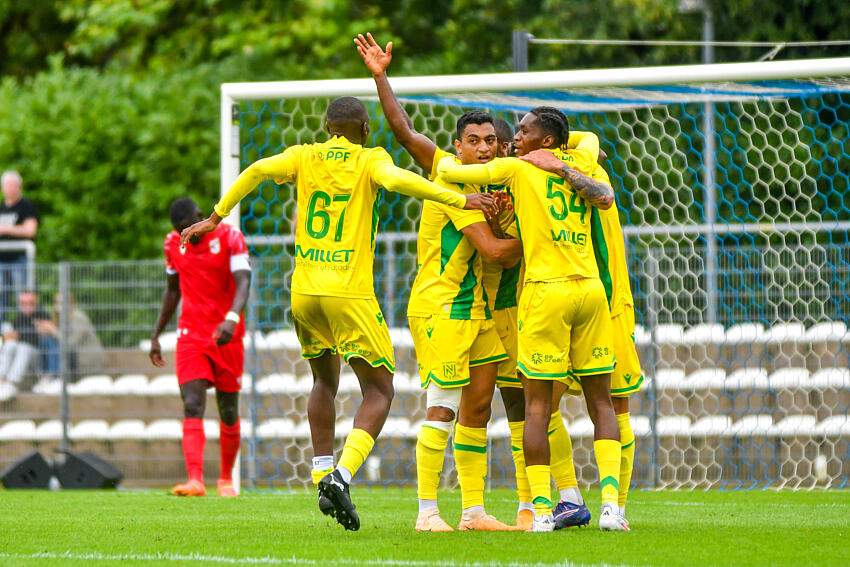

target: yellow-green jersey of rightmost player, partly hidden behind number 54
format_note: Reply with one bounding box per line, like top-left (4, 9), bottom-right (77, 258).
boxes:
top-left (590, 164), bottom-right (635, 317)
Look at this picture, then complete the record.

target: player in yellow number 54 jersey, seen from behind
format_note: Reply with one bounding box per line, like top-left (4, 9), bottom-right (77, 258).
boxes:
top-left (438, 107), bottom-right (620, 531)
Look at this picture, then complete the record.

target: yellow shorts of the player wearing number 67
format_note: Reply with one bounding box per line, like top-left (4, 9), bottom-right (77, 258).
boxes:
top-left (292, 292), bottom-right (395, 372)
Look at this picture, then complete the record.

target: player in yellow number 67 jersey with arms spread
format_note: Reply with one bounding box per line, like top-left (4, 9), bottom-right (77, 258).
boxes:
top-left (181, 97), bottom-right (497, 530)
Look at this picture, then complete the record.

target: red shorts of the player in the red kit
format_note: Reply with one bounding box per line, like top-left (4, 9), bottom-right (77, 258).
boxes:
top-left (177, 336), bottom-right (245, 392)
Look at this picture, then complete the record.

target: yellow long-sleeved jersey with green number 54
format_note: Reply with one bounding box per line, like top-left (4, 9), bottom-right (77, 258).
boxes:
top-left (439, 147), bottom-right (599, 282)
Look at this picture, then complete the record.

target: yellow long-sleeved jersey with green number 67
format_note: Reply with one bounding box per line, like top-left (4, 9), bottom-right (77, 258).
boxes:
top-left (215, 136), bottom-right (466, 299)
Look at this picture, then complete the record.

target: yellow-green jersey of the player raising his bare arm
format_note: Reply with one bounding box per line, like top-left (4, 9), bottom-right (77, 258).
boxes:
top-left (407, 148), bottom-right (490, 319)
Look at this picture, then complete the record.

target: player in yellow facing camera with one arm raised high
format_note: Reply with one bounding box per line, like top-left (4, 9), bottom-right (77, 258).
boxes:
top-left (355, 34), bottom-right (522, 531)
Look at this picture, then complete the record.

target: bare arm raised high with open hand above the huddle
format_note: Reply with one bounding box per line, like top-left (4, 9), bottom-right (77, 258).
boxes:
top-left (354, 33), bottom-right (437, 173)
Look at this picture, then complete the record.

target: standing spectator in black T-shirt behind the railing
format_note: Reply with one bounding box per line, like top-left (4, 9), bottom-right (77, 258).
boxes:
top-left (0, 170), bottom-right (39, 321)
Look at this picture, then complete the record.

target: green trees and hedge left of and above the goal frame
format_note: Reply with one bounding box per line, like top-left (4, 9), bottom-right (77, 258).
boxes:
top-left (0, 0), bottom-right (850, 260)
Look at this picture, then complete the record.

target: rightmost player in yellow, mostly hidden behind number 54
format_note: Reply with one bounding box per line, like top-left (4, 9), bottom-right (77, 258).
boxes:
top-left (525, 140), bottom-right (643, 525)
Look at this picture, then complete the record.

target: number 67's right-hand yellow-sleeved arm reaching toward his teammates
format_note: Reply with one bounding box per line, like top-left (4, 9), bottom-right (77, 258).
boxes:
top-left (373, 163), bottom-right (499, 218)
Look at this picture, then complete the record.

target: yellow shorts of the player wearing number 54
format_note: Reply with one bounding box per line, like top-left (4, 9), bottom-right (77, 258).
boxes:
top-left (517, 278), bottom-right (615, 381)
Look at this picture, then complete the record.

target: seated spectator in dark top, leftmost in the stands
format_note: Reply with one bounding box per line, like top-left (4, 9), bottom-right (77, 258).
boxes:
top-left (0, 291), bottom-right (59, 389)
